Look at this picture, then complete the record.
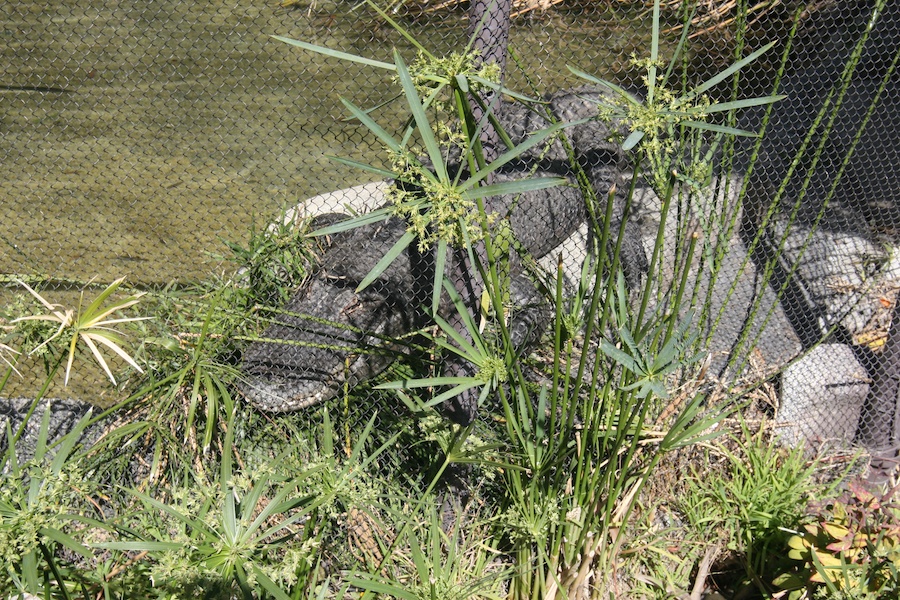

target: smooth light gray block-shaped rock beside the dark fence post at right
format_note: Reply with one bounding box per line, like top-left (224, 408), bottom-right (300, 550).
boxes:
top-left (775, 344), bottom-right (869, 448)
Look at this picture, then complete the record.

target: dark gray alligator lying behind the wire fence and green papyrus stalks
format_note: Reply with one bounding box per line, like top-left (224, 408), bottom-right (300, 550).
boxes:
top-left (241, 88), bottom-right (646, 414)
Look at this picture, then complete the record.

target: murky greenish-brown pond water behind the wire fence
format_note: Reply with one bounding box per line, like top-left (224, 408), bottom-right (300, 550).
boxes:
top-left (0, 0), bottom-right (660, 282)
